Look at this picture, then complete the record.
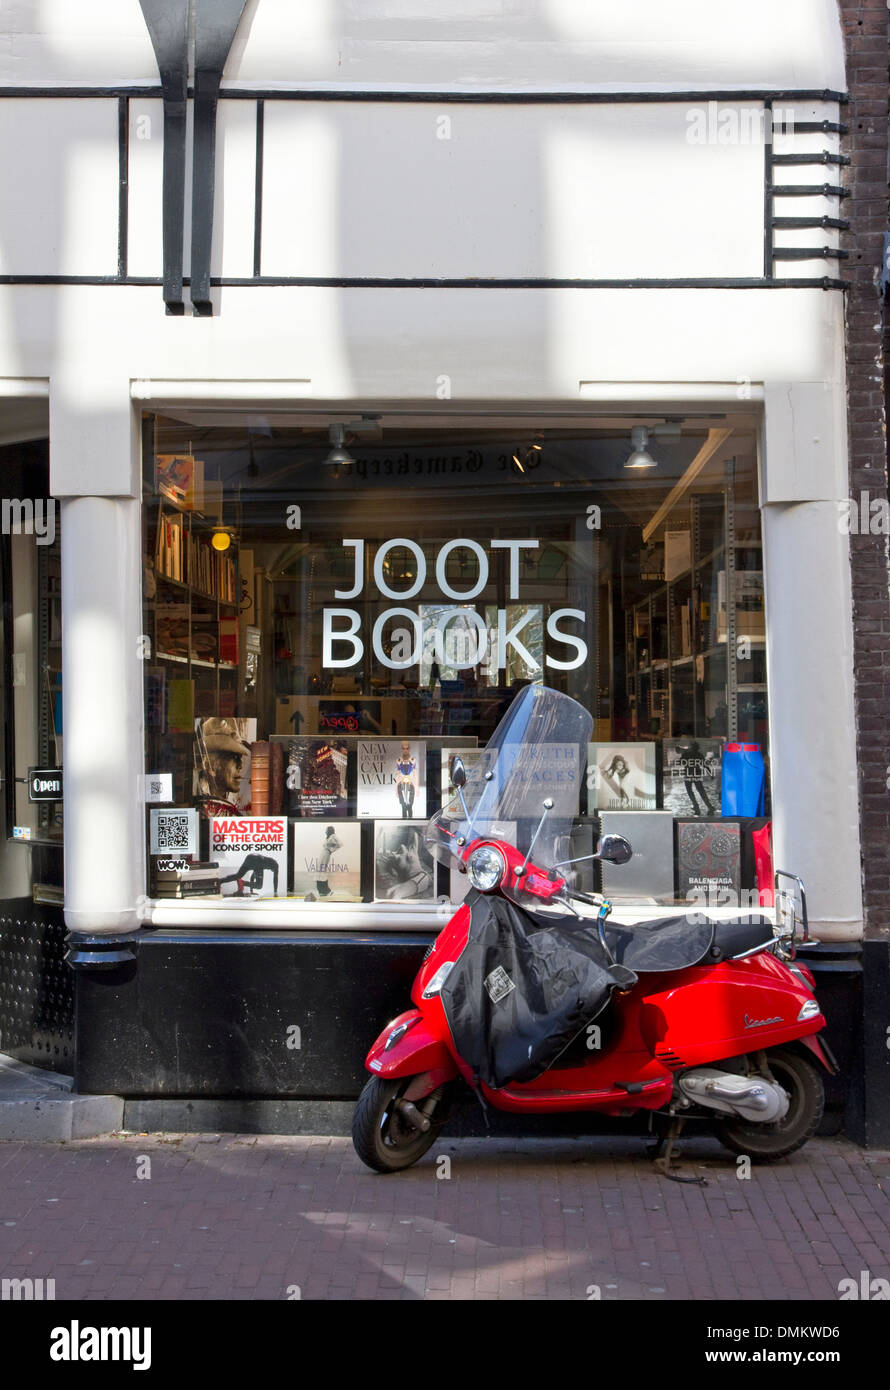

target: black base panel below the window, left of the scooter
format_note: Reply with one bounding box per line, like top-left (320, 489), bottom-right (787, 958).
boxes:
top-left (75, 931), bottom-right (432, 1099)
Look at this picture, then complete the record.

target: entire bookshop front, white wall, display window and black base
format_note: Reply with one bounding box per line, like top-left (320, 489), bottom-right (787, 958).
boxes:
top-left (0, 0), bottom-right (886, 1127)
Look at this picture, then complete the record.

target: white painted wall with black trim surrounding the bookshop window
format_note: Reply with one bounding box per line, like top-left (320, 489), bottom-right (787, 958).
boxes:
top-left (0, 0), bottom-right (862, 938)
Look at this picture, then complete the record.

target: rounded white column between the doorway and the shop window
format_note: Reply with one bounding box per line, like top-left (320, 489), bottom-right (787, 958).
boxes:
top-left (61, 496), bottom-right (145, 934)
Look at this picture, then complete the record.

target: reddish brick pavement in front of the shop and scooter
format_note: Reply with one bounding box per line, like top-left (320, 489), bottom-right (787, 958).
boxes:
top-left (0, 1134), bottom-right (890, 1300)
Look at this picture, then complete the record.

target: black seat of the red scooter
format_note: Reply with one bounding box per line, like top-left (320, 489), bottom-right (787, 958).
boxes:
top-left (605, 917), bottom-right (773, 974)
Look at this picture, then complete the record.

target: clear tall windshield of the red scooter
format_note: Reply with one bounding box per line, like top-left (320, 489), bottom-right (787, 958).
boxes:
top-left (424, 685), bottom-right (594, 892)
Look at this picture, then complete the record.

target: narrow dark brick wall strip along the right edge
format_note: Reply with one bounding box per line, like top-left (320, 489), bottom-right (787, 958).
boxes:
top-left (840, 0), bottom-right (890, 937)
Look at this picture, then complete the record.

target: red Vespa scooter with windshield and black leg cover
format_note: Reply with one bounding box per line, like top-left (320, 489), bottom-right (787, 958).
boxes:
top-left (352, 685), bottom-right (836, 1175)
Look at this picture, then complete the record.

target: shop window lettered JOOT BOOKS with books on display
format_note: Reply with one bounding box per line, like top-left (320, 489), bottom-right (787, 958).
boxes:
top-left (143, 410), bottom-right (769, 924)
